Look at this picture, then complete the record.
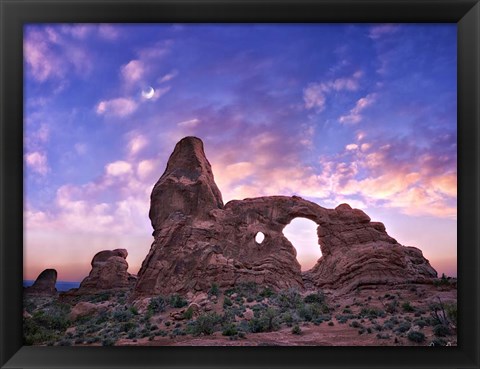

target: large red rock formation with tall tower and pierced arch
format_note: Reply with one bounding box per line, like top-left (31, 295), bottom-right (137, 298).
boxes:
top-left (130, 137), bottom-right (436, 297)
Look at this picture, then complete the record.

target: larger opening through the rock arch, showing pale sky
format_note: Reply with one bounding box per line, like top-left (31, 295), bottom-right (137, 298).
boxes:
top-left (283, 218), bottom-right (322, 271)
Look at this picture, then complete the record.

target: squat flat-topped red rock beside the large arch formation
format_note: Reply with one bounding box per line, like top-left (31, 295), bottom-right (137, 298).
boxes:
top-left (72, 249), bottom-right (135, 294)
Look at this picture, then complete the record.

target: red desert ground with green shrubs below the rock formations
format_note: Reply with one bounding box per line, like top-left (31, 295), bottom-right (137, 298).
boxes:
top-left (24, 276), bottom-right (457, 346)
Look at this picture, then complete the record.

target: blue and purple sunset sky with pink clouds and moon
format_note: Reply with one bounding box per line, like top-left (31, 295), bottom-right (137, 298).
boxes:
top-left (24, 24), bottom-right (457, 281)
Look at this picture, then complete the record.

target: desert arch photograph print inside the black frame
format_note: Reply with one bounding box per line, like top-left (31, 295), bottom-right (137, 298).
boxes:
top-left (23, 23), bottom-right (457, 344)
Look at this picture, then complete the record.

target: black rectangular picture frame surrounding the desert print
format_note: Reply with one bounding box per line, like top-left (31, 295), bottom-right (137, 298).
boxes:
top-left (0, 0), bottom-right (480, 369)
